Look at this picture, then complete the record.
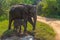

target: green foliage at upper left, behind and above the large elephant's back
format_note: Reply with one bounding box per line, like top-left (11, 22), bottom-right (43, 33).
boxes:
top-left (0, 0), bottom-right (33, 19)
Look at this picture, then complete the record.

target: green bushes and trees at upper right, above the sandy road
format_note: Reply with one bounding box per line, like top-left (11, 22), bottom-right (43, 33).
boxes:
top-left (37, 0), bottom-right (60, 18)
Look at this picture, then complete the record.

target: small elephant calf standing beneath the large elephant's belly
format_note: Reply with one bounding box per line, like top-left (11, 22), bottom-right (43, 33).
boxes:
top-left (13, 19), bottom-right (26, 33)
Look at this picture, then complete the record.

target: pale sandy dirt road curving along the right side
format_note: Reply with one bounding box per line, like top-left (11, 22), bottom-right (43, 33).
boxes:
top-left (37, 16), bottom-right (60, 40)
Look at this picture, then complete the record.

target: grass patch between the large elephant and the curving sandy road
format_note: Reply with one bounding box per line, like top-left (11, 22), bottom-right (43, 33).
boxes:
top-left (35, 22), bottom-right (55, 40)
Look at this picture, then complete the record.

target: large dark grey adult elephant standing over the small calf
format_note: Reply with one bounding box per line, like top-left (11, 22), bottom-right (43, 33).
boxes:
top-left (8, 4), bottom-right (37, 31)
